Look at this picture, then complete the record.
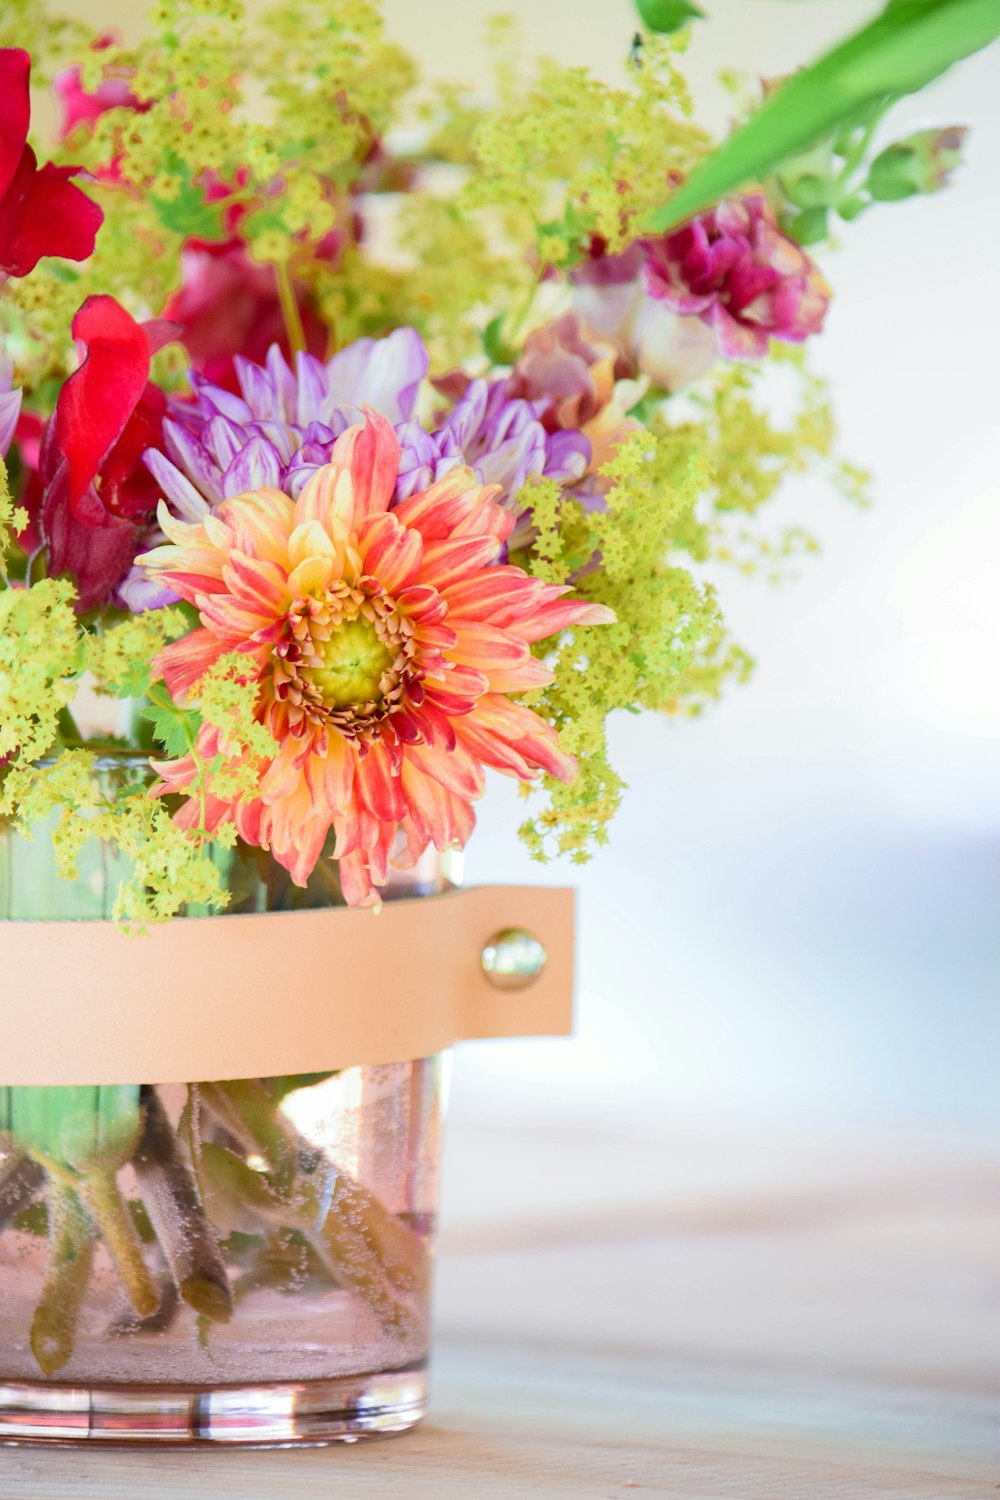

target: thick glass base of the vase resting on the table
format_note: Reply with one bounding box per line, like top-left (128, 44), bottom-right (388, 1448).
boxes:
top-left (0, 1367), bottom-right (427, 1448)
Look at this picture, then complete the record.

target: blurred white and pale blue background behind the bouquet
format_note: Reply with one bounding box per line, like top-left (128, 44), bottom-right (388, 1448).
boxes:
top-left (377, 0), bottom-right (1000, 1133)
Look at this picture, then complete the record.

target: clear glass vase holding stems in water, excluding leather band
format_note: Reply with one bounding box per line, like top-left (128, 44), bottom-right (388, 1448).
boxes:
top-left (0, 771), bottom-right (447, 1446)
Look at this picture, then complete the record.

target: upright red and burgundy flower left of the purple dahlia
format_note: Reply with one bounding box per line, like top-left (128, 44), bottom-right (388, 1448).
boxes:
top-left (39, 297), bottom-right (175, 609)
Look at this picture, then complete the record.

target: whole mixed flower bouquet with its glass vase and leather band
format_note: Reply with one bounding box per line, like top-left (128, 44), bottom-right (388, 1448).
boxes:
top-left (0, 0), bottom-right (983, 1443)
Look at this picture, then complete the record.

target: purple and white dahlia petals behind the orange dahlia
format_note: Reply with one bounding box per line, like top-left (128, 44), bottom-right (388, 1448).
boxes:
top-left (128, 329), bottom-right (591, 612)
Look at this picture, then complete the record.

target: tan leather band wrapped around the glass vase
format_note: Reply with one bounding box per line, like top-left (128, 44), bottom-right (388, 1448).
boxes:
top-left (0, 887), bottom-right (573, 1085)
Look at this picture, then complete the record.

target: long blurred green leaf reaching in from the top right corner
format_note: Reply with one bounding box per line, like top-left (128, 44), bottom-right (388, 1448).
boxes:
top-left (648, 0), bottom-right (1000, 231)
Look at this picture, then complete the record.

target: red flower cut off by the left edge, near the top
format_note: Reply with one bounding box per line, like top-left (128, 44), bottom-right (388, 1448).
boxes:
top-left (0, 47), bottom-right (103, 276)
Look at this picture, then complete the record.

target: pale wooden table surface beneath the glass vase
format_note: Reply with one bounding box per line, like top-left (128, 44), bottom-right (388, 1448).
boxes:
top-left (0, 1127), bottom-right (1000, 1500)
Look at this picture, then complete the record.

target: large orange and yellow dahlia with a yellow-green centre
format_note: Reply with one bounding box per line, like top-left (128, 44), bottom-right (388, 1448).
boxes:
top-left (142, 413), bottom-right (615, 905)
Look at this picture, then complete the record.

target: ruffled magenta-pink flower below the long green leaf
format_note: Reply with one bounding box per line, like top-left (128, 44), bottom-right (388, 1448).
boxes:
top-left (639, 192), bottom-right (829, 359)
